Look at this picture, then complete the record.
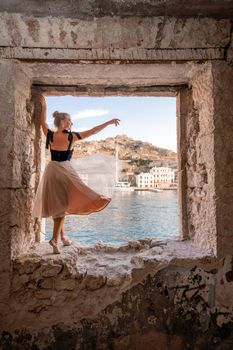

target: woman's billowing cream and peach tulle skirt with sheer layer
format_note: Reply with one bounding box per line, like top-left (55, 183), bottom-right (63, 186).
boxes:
top-left (32, 153), bottom-right (117, 218)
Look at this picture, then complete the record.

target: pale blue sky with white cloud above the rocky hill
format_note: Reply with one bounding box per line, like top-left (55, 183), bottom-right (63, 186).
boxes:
top-left (46, 96), bottom-right (177, 152)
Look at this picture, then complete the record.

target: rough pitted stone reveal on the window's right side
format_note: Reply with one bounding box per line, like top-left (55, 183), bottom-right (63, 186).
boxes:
top-left (186, 65), bottom-right (217, 254)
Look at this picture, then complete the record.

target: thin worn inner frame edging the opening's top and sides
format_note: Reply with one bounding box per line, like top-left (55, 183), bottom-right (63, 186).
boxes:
top-left (32, 83), bottom-right (187, 243)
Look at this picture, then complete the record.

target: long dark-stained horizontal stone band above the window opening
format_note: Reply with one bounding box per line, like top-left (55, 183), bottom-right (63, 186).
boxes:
top-left (0, 13), bottom-right (230, 50)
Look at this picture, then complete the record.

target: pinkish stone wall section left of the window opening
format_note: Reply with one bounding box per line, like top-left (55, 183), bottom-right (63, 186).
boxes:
top-left (0, 60), bottom-right (34, 304)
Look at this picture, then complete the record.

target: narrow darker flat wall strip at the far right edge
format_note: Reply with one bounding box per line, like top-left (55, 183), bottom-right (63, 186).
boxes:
top-left (212, 62), bottom-right (233, 256)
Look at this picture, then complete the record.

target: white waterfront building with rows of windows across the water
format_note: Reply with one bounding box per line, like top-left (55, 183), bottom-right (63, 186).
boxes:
top-left (136, 167), bottom-right (175, 188)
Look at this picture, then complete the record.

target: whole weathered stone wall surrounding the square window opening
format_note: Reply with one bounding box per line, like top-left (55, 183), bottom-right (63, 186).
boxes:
top-left (0, 4), bottom-right (233, 350)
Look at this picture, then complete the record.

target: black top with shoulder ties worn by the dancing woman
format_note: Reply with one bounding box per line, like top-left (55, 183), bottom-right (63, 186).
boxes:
top-left (46, 129), bottom-right (81, 162)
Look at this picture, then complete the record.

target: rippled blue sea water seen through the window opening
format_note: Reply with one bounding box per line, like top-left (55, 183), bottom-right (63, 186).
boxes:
top-left (45, 190), bottom-right (179, 244)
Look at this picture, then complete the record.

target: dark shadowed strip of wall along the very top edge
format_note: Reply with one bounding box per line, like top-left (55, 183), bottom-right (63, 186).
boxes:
top-left (0, 0), bottom-right (233, 20)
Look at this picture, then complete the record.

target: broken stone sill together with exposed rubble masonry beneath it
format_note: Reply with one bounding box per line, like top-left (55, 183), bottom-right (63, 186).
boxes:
top-left (9, 239), bottom-right (212, 329)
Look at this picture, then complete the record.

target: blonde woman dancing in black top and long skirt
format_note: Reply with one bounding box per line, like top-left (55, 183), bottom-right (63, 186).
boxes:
top-left (32, 95), bottom-right (120, 254)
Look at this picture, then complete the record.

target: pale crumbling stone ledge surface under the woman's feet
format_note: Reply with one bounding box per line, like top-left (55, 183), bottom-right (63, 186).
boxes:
top-left (14, 238), bottom-right (213, 290)
